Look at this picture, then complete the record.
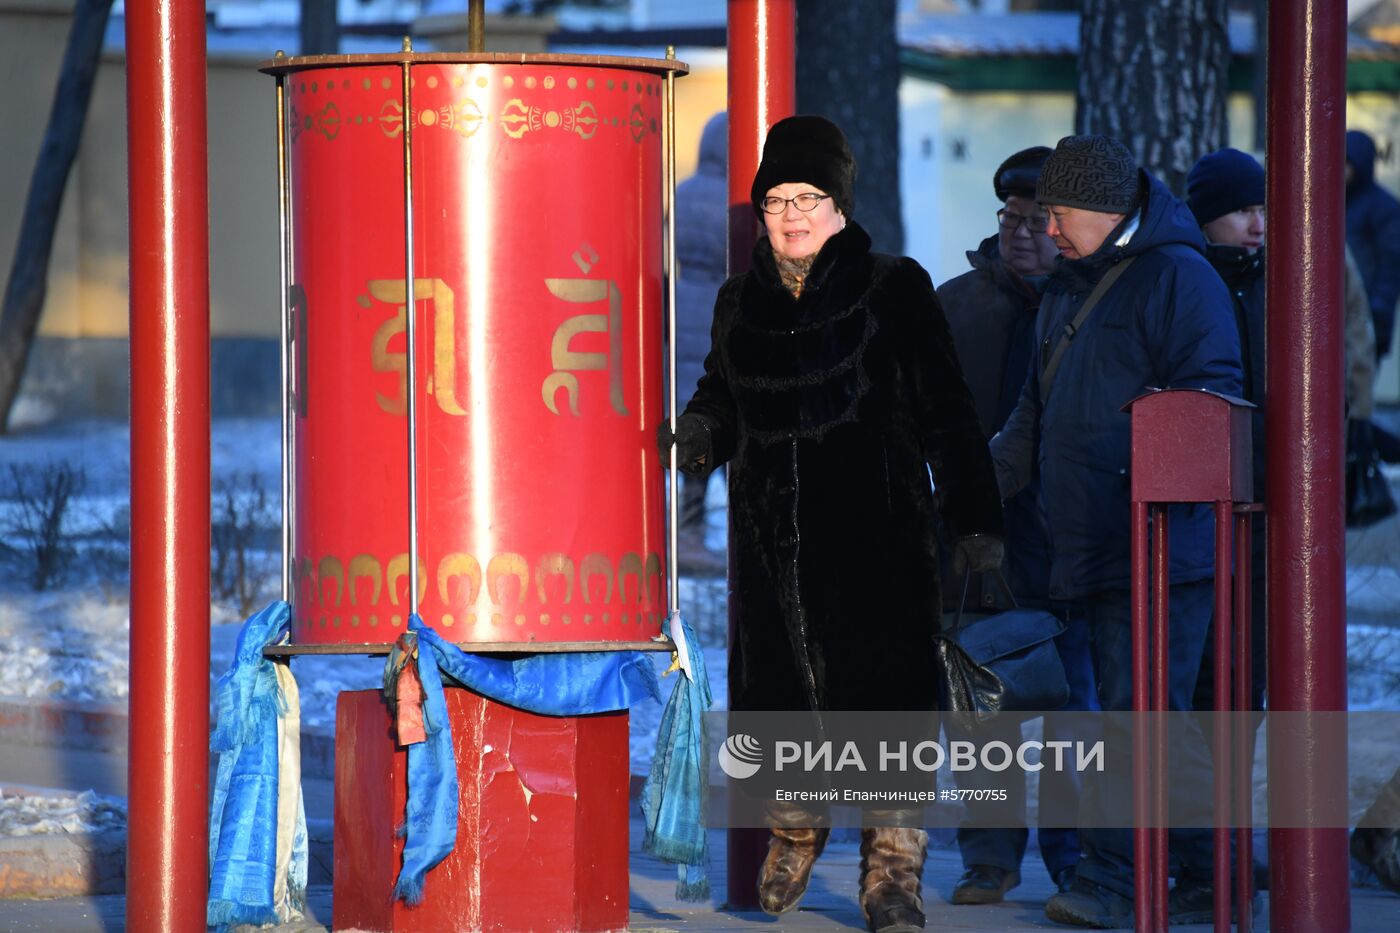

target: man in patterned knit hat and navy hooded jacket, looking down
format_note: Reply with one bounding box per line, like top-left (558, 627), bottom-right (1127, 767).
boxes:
top-left (991, 136), bottom-right (1243, 929)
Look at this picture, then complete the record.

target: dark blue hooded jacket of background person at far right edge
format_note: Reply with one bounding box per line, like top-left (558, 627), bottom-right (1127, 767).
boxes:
top-left (1347, 130), bottom-right (1400, 357)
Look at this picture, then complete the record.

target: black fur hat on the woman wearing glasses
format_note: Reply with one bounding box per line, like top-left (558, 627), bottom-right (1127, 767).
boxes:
top-left (749, 115), bottom-right (855, 217)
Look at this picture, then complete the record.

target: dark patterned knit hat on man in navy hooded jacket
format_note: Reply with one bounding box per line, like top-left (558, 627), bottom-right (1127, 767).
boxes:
top-left (1036, 134), bottom-right (1138, 214)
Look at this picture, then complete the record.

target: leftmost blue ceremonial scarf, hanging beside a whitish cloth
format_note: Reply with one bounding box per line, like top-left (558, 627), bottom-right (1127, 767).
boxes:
top-left (207, 600), bottom-right (307, 927)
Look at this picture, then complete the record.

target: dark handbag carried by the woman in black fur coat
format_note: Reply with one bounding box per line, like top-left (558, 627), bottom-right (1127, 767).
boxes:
top-left (934, 570), bottom-right (1070, 720)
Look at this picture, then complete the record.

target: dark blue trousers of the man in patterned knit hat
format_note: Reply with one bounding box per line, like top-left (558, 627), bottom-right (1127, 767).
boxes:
top-left (1070, 580), bottom-right (1214, 897)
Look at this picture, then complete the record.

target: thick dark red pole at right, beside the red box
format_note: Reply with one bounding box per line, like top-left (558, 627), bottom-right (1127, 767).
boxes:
top-left (1266, 0), bottom-right (1351, 933)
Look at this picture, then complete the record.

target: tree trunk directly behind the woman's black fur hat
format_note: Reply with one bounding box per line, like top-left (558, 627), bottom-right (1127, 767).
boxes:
top-left (797, 0), bottom-right (904, 255)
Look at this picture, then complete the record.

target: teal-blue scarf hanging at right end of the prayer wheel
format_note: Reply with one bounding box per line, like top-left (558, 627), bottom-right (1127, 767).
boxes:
top-left (641, 612), bottom-right (711, 901)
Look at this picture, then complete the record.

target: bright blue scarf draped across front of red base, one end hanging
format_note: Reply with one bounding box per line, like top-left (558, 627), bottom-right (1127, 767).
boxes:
top-left (393, 615), bottom-right (661, 904)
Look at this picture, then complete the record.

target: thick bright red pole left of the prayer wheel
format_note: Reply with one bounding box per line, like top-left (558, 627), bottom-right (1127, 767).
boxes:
top-left (126, 0), bottom-right (209, 933)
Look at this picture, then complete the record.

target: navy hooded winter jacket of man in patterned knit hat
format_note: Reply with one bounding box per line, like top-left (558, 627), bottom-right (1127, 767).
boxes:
top-left (991, 172), bottom-right (1243, 600)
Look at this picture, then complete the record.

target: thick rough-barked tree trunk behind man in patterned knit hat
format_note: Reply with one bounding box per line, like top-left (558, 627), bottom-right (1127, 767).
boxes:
top-left (1074, 0), bottom-right (1229, 195)
